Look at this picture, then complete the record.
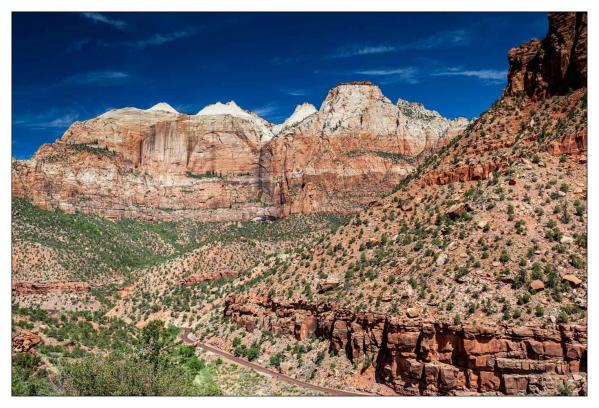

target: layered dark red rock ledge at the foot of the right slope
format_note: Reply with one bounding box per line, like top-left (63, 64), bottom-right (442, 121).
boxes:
top-left (225, 294), bottom-right (587, 395)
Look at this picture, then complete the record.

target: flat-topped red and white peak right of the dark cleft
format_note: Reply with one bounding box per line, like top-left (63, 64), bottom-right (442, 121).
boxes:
top-left (262, 82), bottom-right (468, 215)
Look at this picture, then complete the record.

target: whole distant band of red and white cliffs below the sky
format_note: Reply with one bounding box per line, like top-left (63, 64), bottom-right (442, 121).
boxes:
top-left (12, 83), bottom-right (468, 221)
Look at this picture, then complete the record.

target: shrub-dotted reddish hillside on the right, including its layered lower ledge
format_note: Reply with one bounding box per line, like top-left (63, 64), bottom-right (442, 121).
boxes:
top-left (217, 13), bottom-right (587, 395)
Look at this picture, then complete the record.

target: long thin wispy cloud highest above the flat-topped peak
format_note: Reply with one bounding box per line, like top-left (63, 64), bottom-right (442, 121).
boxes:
top-left (329, 30), bottom-right (472, 58)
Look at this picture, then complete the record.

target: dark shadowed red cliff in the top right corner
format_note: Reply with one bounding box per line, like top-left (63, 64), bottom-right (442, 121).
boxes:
top-left (505, 13), bottom-right (587, 99)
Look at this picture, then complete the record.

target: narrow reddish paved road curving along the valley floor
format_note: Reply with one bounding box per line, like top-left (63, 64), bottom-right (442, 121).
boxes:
top-left (181, 329), bottom-right (373, 397)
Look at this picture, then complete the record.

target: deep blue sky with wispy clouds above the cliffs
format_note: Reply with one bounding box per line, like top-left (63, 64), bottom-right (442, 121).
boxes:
top-left (12, 12), bottom-right (547, 159)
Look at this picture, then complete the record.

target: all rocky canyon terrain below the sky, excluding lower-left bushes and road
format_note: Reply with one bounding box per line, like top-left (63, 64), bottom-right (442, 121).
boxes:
top-left (12, 13), bottom-right (588, 395)
